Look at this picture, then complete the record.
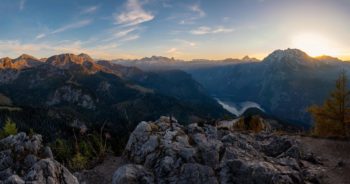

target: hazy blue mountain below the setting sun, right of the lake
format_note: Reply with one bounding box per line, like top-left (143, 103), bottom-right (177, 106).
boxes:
top-left (189, 49), bottom-right (350, 126)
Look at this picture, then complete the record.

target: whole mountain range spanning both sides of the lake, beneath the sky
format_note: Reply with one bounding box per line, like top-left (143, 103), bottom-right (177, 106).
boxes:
top-left (0, 49), bottom-right (350, 135)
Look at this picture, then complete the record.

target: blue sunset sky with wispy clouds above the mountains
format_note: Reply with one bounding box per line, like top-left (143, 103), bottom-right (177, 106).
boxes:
top-left (0, 0), bottom-right (350, 60)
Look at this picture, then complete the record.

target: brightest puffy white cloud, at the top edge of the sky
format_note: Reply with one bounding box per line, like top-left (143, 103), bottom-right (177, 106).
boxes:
top-left (114, 0), bottom-right (154, 26)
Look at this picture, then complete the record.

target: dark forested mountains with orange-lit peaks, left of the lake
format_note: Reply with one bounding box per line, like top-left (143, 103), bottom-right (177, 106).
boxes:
top-left (0, 54), bottom-right (233, 147)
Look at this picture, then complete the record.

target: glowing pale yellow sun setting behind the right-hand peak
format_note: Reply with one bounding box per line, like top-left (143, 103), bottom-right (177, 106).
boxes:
top-left (292, 33), bottom-right (334, 57)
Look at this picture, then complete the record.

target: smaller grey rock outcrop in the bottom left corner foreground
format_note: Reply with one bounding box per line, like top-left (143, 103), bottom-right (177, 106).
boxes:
top-left (0, 133), bottom-right (78, 184)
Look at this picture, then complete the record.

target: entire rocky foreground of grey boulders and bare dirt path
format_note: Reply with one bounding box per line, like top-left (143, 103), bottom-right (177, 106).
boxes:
top-left (0, 117), bottom-right (342, 184)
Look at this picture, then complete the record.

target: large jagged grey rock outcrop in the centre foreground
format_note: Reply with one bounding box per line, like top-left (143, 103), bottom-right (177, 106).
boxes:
top-left (113, 117), bottom-right (323, 184)
